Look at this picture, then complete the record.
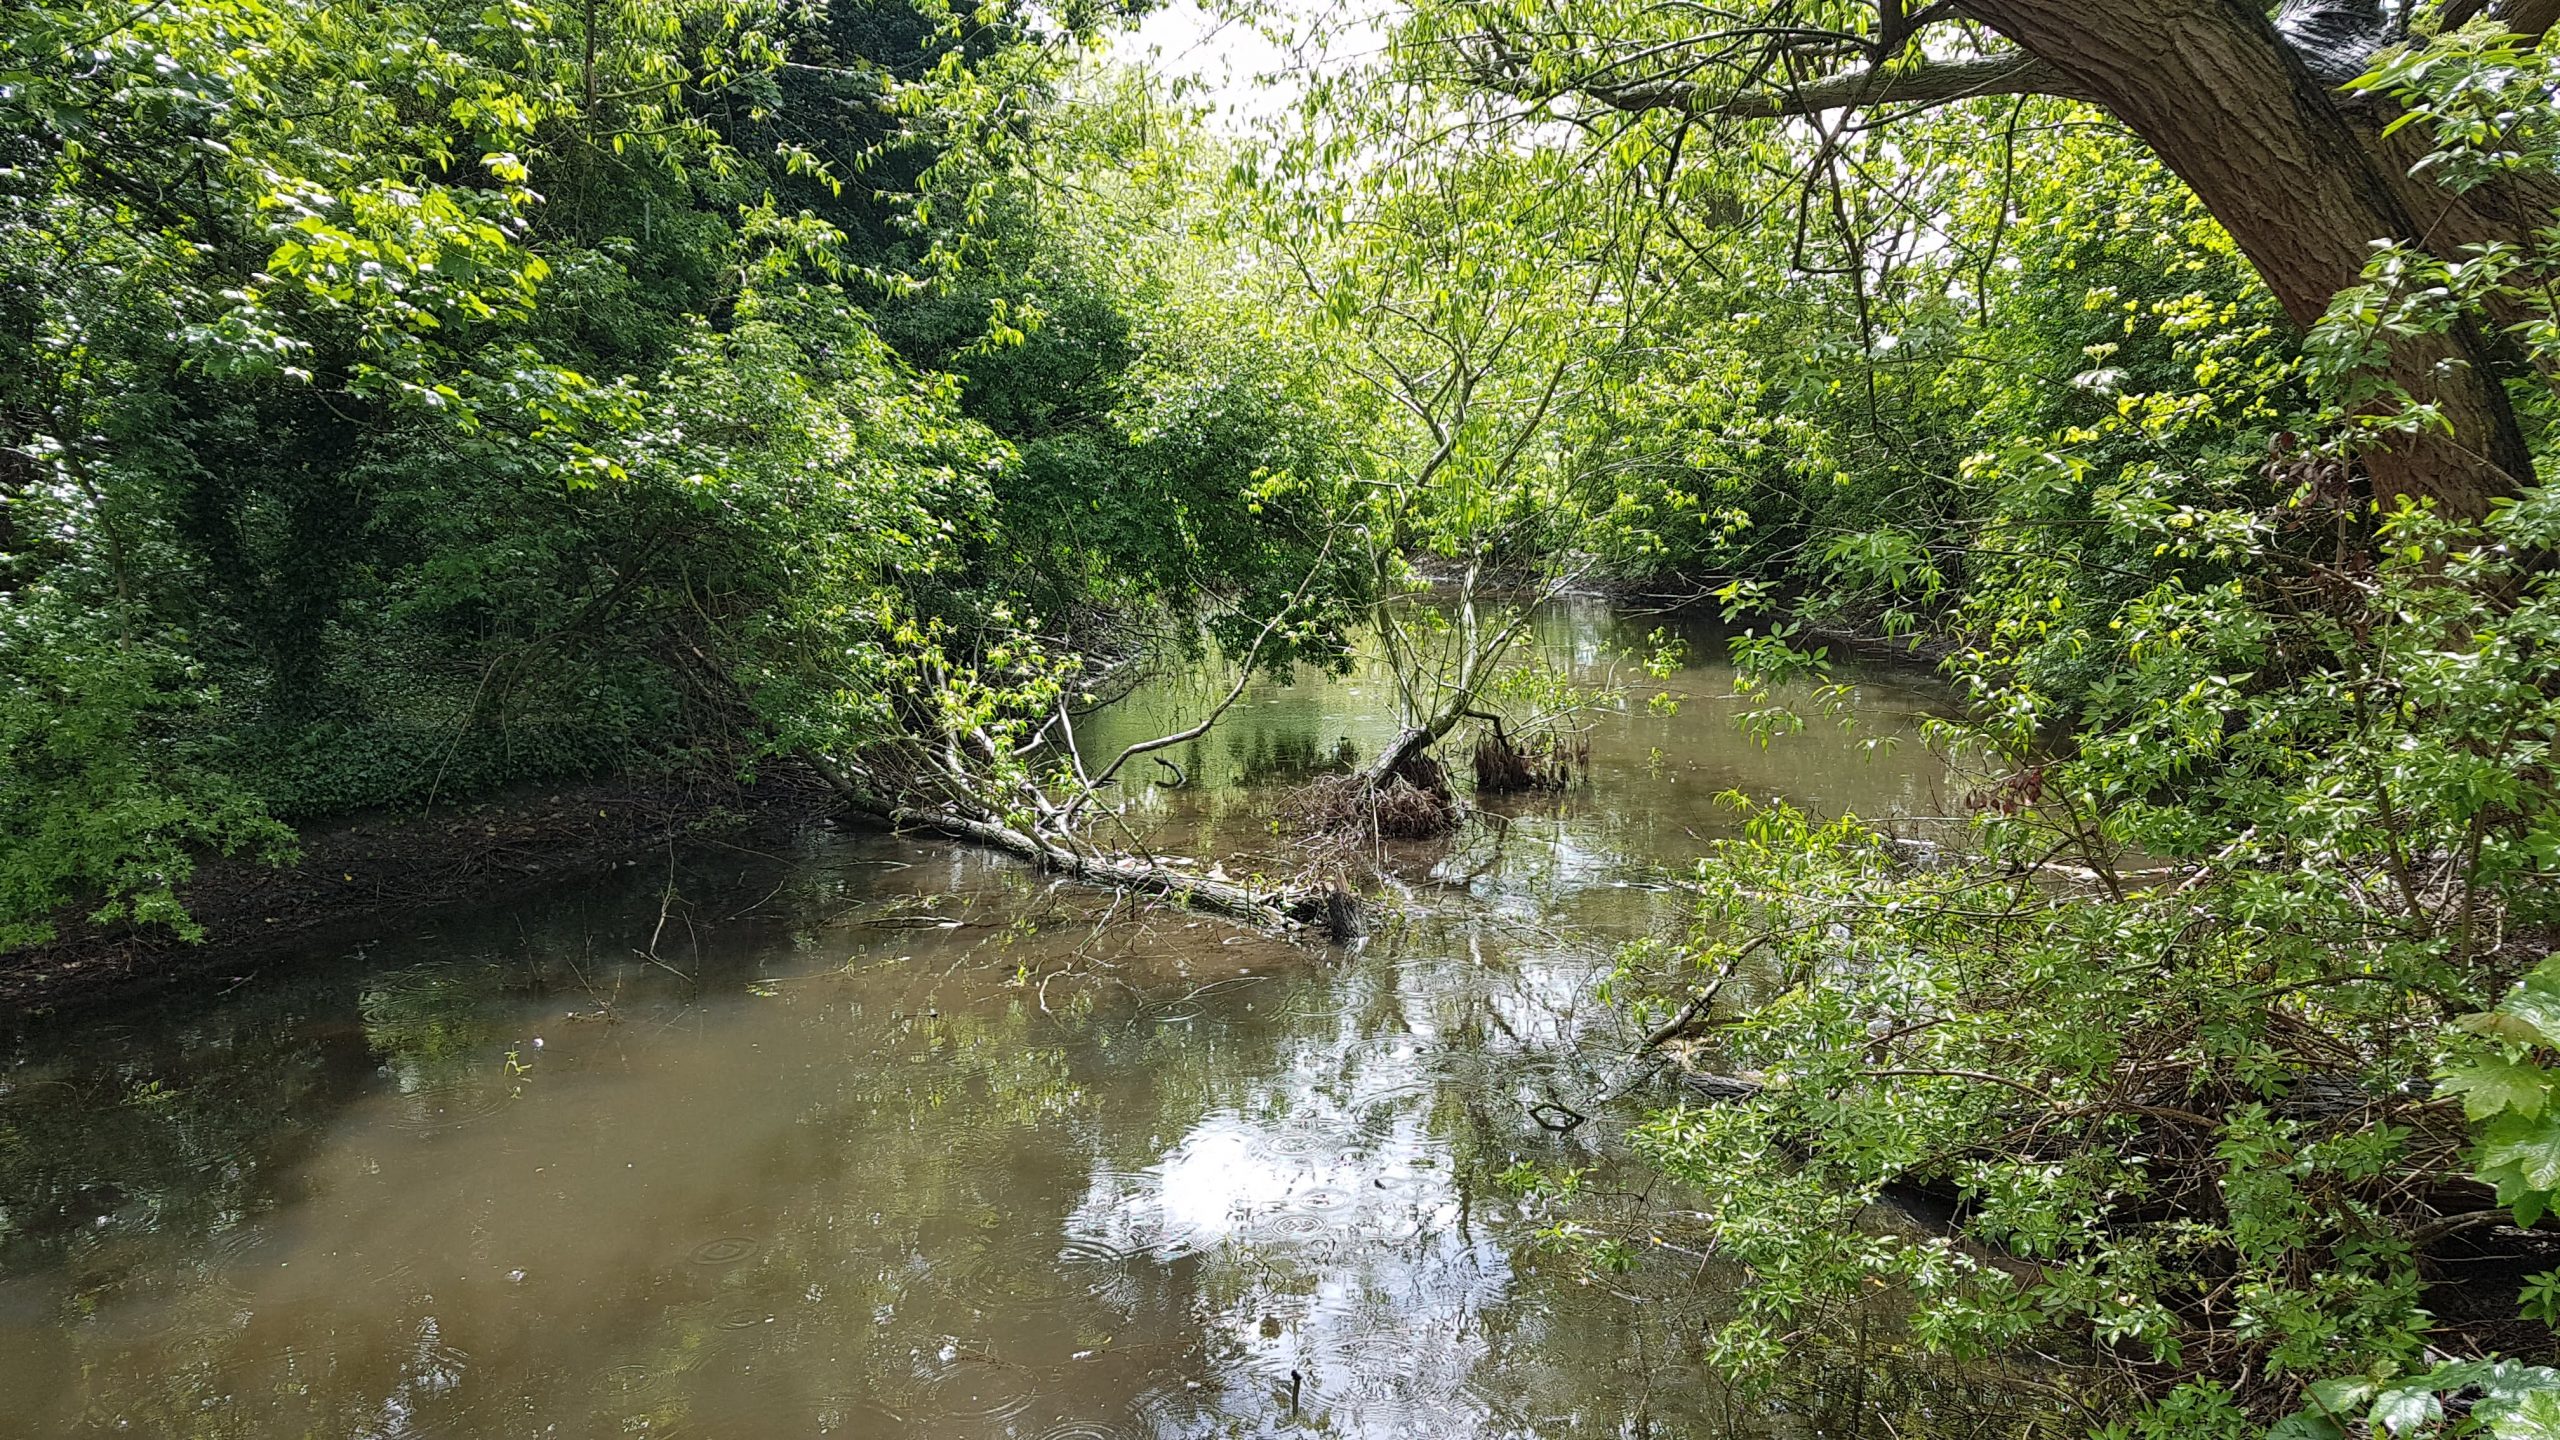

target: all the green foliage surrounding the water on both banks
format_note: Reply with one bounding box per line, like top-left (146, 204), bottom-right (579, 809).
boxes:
top-left (15, 0), bottom-right (2560, 1440)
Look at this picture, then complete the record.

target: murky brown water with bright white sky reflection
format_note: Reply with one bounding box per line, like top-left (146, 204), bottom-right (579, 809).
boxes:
top-left (0, 605), bottom-right (2037, 1440)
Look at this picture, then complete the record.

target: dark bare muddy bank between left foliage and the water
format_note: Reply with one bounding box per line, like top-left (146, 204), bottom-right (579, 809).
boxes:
top-left (0, 766), bottom-right (837, 1015)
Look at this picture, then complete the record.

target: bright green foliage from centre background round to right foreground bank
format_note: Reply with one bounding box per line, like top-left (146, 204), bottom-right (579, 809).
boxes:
top-left (1162, 3), bottom-right (2560, 1437)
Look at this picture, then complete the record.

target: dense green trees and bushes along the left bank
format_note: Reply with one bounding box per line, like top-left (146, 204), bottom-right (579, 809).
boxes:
top-left (0, 0), bottom-right (1357, 945)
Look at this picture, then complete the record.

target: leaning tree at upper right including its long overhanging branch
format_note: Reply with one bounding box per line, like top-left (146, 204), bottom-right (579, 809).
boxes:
top-left (1443, 0), bottom-right (2560, 515)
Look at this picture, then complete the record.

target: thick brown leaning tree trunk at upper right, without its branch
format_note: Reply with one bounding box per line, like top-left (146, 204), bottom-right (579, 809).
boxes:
top-left (1964, 0), bottom-right (2532, 518)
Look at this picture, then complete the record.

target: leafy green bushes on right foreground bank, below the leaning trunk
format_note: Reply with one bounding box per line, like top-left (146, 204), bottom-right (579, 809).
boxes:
top-left (1620, 41), bottom-right (2560, 1440)
